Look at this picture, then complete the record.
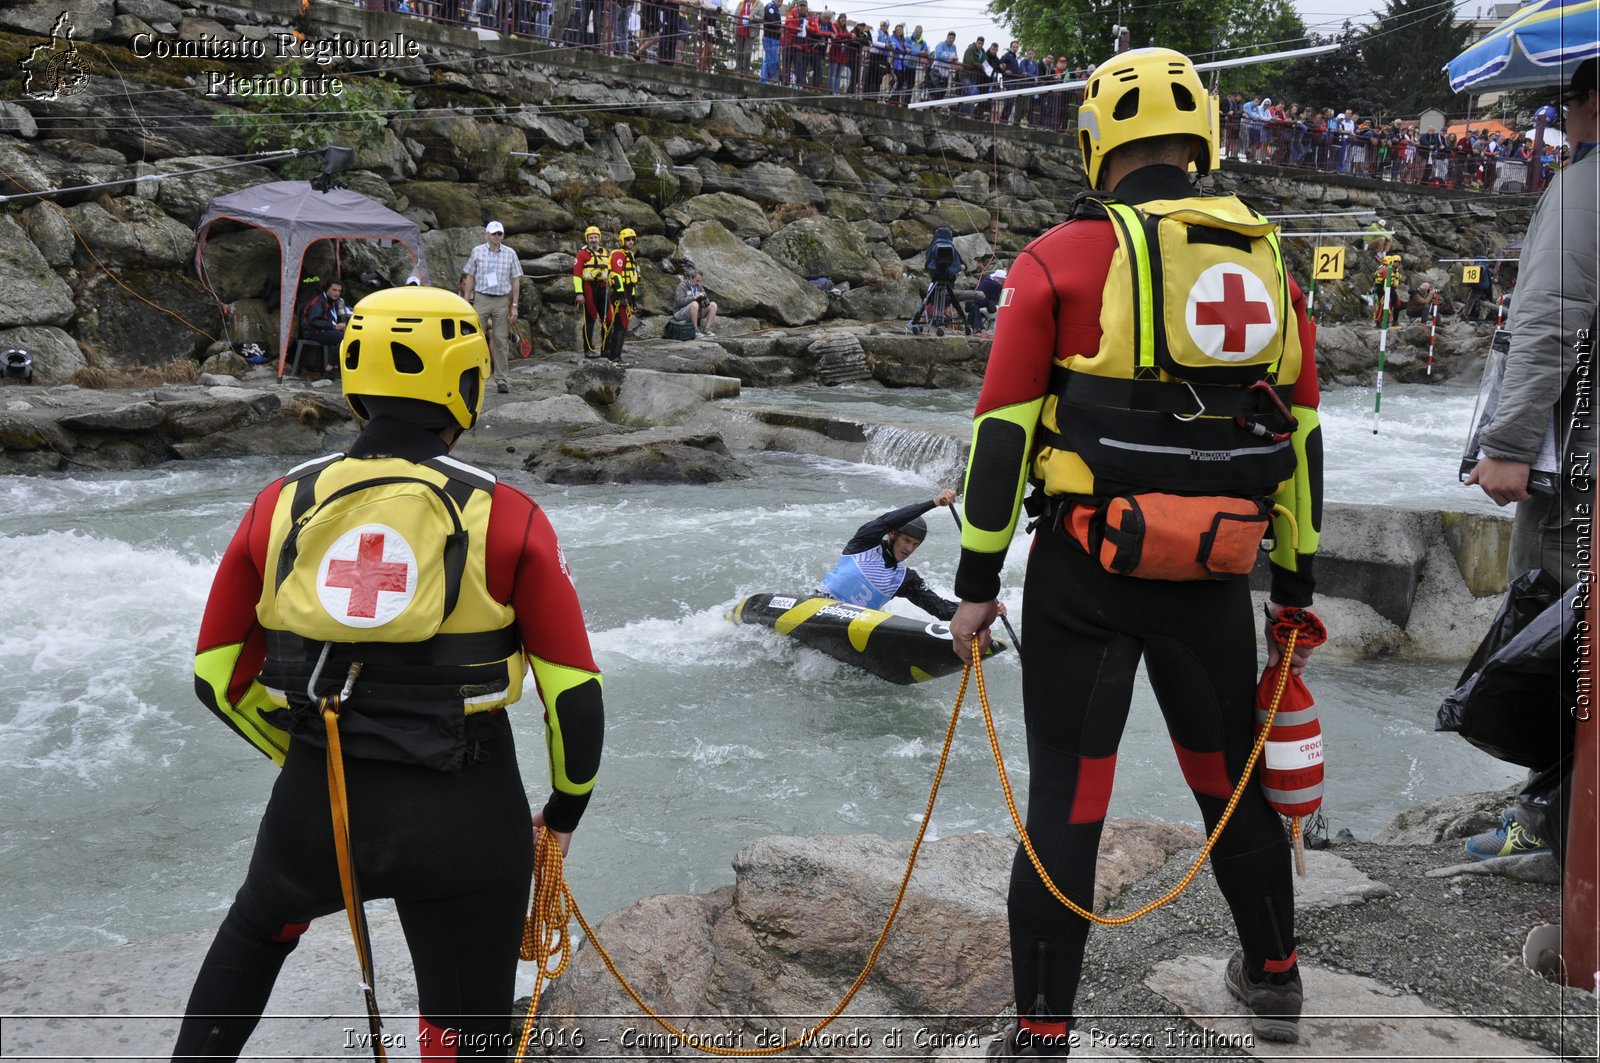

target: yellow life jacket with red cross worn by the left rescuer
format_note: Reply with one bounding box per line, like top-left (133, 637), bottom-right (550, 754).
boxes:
top-left (256, 455), bottom-right (525, 770)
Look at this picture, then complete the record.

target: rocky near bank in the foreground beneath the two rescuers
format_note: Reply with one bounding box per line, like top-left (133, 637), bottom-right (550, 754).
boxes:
top-left (0, 792), bottom-right (1597, 1061)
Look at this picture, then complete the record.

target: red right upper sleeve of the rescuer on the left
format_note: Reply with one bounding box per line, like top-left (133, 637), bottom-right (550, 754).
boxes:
top-left (488, 483), bottom-right (600, 672)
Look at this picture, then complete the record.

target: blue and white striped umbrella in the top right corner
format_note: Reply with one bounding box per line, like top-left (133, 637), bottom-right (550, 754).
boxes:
top-left (1445, 0), bottom-right (1600, 93)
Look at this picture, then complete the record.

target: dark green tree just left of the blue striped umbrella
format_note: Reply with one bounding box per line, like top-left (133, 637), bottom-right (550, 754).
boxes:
top-left (1362, 0), bottom-right (1470, 115)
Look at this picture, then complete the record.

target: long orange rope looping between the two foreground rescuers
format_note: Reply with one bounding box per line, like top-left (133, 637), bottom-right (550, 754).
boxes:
top-left (515, 634), bottom-right (1296, 1063)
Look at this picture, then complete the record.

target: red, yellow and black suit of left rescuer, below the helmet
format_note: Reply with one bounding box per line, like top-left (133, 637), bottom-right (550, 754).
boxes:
top-left (174, 418), bottom-right (603, 1058)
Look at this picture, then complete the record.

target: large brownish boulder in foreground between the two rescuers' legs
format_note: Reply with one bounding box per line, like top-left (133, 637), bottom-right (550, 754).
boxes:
top-left (541, 820), bottom-right (1203, 1058)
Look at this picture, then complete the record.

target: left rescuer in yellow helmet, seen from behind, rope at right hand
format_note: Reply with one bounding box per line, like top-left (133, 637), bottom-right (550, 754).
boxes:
top-left (173, 288), bottom-right (603, 1060)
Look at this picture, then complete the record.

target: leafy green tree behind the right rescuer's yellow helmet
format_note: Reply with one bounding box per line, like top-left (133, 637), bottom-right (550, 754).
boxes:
top-left (989, 0), bottom-right (1306, 69)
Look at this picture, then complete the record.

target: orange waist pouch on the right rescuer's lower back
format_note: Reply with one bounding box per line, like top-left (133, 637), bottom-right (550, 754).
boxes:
top-left (1062, 491), bottom-right (1272, 581)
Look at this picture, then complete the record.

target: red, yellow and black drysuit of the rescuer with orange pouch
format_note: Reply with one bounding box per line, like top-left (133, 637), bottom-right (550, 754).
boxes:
top-left (955, 166), bottom-right (1322, 1034)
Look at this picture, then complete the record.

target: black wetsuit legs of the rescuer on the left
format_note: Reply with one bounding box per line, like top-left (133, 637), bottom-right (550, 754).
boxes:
top-left (173, 714), bottom-right (533, 1060)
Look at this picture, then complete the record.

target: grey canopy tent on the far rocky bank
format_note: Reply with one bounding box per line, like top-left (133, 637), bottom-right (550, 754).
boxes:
top-left (195, 181), bottom-right (427, 378)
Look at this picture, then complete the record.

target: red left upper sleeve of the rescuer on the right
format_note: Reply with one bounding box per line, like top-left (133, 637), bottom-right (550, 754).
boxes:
top-left (976, 219), bottom-right (1117, 416)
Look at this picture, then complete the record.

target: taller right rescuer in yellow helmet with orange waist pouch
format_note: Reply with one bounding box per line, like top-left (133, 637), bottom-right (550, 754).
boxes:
top-left (950, 48), bottom-right (1322, 1058)
